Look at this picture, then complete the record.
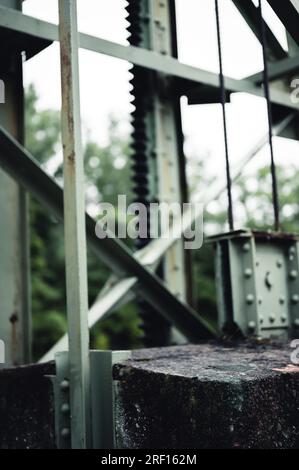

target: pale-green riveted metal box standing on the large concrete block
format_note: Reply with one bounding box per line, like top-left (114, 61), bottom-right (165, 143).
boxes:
top-left (212, 230), bottom-right (299, 338)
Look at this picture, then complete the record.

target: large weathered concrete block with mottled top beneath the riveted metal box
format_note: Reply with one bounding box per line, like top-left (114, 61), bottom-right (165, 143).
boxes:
top-left (114, 344), bottom-right (299, 449)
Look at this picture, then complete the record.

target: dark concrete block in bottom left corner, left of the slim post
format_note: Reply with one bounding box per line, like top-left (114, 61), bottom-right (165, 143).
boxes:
top-left (0, 363), bottom-right (55, 449)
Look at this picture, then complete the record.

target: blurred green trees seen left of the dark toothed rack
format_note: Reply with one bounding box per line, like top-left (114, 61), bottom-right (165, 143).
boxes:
top-left (26, 85), bottom-right (140, 358)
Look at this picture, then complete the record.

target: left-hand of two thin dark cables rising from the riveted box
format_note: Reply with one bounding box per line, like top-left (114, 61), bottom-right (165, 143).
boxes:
top-left (215, 0), bottom-right (234, 230)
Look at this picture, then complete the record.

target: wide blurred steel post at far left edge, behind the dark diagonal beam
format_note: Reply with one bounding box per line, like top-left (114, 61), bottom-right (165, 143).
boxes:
top-left (0, 0), bottom-right (31, 367)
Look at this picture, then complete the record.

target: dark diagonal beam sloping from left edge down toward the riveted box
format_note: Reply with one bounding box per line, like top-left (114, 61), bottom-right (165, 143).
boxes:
top-left (0, 127), bottom-right (217, 341)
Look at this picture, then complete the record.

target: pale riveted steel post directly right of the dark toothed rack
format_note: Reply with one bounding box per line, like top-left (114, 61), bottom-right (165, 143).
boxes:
top-left (149, 0), bottom-right (187, 301)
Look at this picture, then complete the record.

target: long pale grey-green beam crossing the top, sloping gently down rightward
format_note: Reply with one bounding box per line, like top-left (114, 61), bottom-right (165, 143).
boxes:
top-left (0, 6), bottom-right (298, 109)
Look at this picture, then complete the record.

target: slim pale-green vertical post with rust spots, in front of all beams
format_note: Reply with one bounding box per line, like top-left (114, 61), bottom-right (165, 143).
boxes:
top-left (59, 0), bottom-right (90, 449)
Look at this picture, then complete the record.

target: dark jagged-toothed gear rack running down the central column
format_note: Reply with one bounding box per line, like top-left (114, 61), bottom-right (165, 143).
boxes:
top-left (126, 0), bottom-right (170, 347)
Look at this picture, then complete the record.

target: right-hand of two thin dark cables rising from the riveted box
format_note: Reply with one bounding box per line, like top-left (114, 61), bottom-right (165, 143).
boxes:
top-left (258, 0), bottom-right (280, 231)
